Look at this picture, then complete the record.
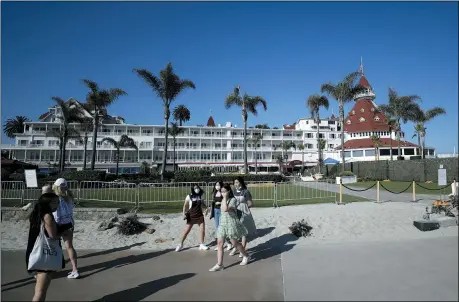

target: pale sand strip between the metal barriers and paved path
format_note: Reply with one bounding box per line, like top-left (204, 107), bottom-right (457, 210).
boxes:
top-left (2, 202), bottom-right (458, 252)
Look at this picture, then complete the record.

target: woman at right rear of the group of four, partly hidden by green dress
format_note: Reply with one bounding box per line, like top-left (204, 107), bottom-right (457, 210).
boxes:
top-left (230, 176), bottom-right (257, 257)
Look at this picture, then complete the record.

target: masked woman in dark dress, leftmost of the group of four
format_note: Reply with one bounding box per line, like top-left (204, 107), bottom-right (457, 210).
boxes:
top-left (175, 185), bottom-right (209, 252)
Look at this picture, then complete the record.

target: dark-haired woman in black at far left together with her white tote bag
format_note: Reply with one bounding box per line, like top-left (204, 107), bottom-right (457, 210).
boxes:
top-left (26, 193), bottom-right (65, 301)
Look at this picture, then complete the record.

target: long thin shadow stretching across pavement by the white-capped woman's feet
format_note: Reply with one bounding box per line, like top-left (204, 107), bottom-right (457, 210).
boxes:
top-left (2, 249), bottom-right (172, 292)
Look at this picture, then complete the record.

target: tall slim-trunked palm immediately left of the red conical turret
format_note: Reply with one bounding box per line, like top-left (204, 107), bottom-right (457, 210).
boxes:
top-left (320, 72), bottom-right (367, 171)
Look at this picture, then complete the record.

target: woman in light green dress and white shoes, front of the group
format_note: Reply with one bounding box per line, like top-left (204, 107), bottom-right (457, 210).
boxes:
top-left (209, 184), bottom-right (249, 272)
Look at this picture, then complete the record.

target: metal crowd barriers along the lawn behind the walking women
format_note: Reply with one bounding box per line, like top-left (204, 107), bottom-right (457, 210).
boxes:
top-left (1, 180), bottom-right (337, 207)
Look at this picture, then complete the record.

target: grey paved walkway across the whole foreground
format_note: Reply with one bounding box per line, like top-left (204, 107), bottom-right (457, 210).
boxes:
top-left (1, 235), bottom-right (458, 301)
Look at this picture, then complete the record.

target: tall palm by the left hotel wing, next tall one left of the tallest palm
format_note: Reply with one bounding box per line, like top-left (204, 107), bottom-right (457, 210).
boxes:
top-left (82, 79), bottom-right (127, 170)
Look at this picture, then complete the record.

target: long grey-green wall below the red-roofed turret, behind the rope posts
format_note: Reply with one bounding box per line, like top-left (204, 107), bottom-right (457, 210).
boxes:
top-left (344, 158), bottom-right (459, 182)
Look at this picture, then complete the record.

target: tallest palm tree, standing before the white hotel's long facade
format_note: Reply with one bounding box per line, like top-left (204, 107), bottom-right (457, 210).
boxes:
top-left (133, 63), bottom-right (196, 179)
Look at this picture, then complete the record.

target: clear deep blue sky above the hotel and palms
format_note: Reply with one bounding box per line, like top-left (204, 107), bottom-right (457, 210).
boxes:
top-left (1, 2), bottom-right (458, 153)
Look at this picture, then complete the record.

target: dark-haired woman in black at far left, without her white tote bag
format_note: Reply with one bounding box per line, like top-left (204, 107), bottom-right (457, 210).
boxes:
top-left (26, 193), bottom-right (65, 301)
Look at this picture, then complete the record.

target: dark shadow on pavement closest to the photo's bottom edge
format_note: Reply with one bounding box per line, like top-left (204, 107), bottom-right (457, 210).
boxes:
top-left (94, 273), bottom-right (196, 301)
